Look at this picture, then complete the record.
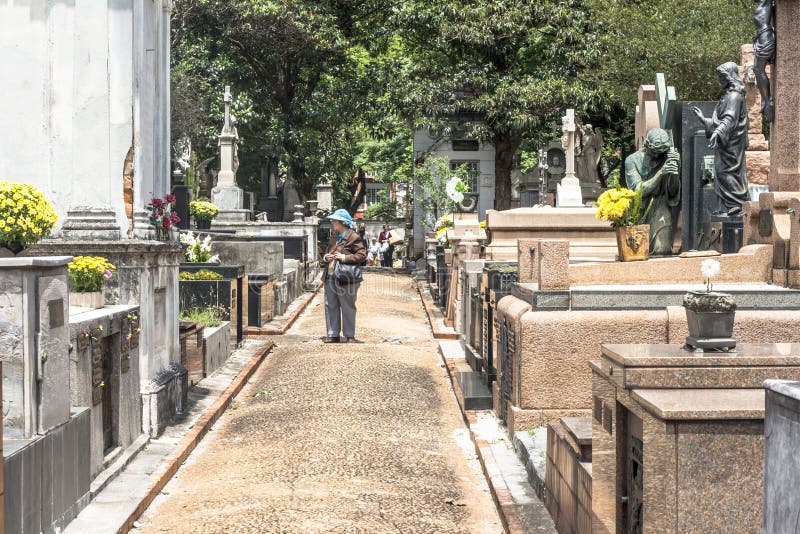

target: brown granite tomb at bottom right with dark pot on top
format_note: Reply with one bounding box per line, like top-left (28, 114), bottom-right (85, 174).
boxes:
top-left (590, 343), bottom-right (800, 532)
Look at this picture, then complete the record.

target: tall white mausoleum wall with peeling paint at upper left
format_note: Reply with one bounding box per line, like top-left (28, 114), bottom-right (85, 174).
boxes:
top-left (0, 0), bottom-right (170, 235)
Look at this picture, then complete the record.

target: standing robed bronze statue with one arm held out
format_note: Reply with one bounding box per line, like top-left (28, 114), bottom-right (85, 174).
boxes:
top-left (692, 62), bottom-right (750, 217)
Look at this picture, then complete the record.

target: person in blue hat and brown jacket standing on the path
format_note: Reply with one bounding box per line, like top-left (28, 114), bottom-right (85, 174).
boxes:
top-left (322, 209), bottom-right (367, 343)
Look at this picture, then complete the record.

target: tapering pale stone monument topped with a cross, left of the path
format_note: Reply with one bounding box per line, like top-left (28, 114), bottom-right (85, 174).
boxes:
top-left (211, 86), bottom-right (249, 221)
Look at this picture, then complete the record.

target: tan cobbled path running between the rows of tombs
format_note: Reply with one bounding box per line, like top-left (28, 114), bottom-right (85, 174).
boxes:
top-left (135, 272), bottom-right (503, 534)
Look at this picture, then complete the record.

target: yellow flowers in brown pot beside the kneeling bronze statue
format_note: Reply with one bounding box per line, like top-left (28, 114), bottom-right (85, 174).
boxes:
top-left (597, 182), bottom-right (653, 261)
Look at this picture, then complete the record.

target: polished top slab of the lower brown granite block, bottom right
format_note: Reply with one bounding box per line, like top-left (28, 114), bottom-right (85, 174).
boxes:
top-left (631, 389), bottom-right (764, 421)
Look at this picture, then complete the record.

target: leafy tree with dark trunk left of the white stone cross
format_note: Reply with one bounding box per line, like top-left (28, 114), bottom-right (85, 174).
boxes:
top-left (396, 0), bottom-right (601, 209)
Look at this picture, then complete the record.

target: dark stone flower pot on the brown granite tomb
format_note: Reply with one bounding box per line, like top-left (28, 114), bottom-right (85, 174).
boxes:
top-left (683, 291), bottom-right (736, 350)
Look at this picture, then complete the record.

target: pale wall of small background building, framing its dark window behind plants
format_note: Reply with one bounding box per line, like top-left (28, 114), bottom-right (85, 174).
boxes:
top-left (414, 128), bottom-right (494, 254)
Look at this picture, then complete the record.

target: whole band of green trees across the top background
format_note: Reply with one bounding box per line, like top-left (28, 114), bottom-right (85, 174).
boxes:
top-left (172, 0), bottom-right (753, 215)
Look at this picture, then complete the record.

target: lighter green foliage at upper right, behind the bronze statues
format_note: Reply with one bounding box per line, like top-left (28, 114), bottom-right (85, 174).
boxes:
top-left (590, 0), bottom-right (754, 147)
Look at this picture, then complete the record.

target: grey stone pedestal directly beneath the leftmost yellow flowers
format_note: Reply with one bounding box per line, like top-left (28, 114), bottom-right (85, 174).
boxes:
top-left (0, 256), bottom-right (72, 437)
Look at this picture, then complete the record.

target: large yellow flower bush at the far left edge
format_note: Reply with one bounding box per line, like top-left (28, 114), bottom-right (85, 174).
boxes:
top-left (0, 181), bottom-right (58, 256)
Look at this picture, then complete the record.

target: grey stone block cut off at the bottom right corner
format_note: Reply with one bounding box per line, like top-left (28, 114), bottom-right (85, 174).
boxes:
top-left (763, 380), bottom-right (800, 532)
